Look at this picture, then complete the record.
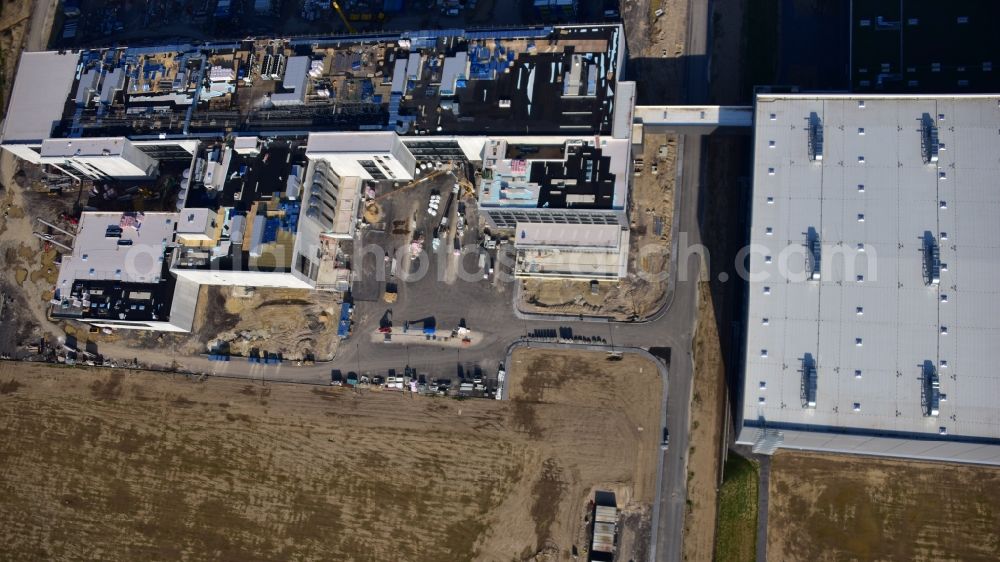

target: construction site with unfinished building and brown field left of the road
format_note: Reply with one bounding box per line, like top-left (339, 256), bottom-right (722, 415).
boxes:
top-left (0, 5), bottom-right (679, 560)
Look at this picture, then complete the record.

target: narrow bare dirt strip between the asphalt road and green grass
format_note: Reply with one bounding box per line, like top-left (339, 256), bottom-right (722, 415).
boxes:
top-left (684, 283), bottom-right (725, 560)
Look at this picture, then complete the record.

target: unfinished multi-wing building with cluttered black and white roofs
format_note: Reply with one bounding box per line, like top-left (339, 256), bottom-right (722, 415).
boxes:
top-left (0, 25), bottom-right (635, 331)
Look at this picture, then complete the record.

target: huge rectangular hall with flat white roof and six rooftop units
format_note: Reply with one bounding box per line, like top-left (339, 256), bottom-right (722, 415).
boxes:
top-left (738, 95), bottom-right (1000, 464)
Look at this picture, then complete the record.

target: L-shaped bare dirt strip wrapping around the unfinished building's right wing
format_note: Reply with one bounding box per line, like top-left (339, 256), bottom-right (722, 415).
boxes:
top-left (518, 130), bottom-right (677, 320)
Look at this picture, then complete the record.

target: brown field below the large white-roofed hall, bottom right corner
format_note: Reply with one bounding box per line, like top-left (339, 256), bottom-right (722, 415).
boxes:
top-left (767, 451), bottom-right (1000, 561)
